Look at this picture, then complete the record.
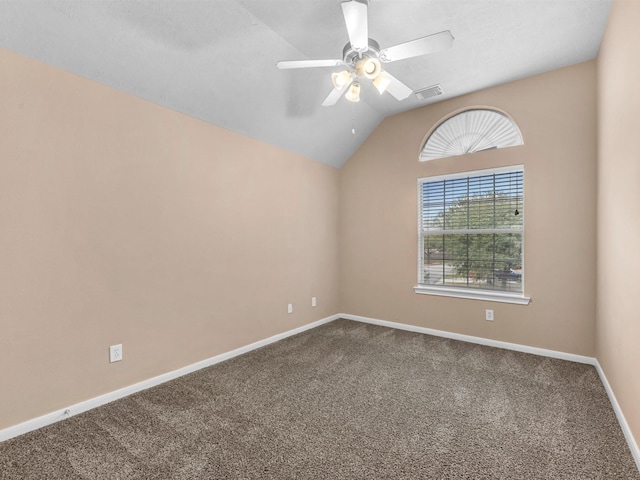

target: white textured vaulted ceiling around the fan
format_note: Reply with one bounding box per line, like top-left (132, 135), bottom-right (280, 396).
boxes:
top-left (0, 0), bottom-right (612, 167)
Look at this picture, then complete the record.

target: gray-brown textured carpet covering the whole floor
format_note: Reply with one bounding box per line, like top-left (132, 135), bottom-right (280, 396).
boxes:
top-left (0, 320), bottom-right (640, 480)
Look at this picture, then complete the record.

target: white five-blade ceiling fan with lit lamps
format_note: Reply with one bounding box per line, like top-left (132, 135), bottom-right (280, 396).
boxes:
top-left (276, 0), bottom-right (453, 107)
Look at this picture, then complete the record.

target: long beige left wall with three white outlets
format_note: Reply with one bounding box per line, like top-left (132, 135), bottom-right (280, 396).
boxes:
top-left (0, 50), bottom-right (338, 429)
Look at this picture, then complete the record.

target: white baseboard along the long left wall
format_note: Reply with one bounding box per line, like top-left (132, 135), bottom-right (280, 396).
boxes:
top-left (0, 315), bottom-right (340, 442)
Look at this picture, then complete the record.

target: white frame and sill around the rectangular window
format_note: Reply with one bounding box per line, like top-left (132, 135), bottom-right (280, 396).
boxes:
top-left (413, 165), bottom-right (531, 305)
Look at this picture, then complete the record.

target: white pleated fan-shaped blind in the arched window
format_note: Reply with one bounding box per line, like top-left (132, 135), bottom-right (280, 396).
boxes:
top-left (420, 108), bottom-right (524, 162)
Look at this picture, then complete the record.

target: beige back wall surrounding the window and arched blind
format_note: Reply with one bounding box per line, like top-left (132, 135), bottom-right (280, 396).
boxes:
top-left (340, 61), bottom-right (596, 356)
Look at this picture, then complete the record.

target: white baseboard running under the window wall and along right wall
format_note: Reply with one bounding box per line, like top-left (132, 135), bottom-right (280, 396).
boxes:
top-left (337, 313), bottom-right (640, 471)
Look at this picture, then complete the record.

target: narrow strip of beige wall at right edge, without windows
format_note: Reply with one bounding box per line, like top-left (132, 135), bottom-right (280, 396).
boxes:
top-left (596, 0), bottom-right (640, 450)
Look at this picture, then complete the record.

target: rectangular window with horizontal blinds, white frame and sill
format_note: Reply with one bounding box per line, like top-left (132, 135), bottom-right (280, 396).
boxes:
top-left (415, 166), bottom-right (529, 304)
